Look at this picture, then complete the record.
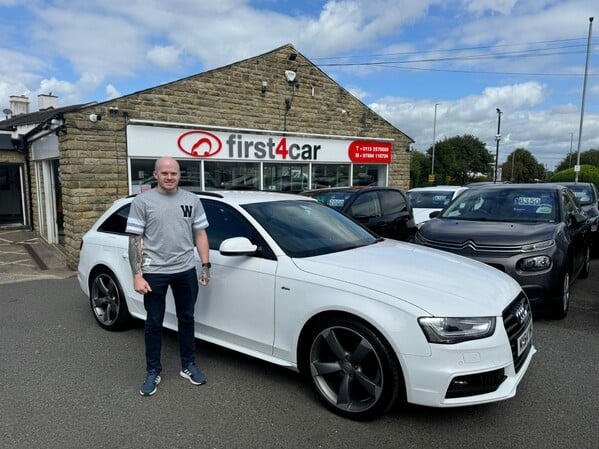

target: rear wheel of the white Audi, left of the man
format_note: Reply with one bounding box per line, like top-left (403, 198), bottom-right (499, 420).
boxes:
top-left (89, 268), bottom-right (131, 331)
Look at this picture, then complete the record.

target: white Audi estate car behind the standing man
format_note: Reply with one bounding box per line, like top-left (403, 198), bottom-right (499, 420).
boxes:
top-left (78, 190), bottom-right (536, 419)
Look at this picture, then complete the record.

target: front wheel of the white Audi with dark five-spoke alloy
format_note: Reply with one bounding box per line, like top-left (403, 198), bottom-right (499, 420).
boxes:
top-left (308, 319), bottom-right (404, 420)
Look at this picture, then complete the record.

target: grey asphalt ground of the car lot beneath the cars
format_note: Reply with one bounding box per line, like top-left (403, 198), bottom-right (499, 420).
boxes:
top-left (0, 231), bottom-right (599, 449)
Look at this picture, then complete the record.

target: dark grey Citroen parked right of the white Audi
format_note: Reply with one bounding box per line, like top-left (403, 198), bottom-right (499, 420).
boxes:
top-left (415, 184), bottom-right (590, 319)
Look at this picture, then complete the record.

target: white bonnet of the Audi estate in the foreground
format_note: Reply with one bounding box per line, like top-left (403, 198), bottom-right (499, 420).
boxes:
top-left (294, 240), bottom-right (521, 317)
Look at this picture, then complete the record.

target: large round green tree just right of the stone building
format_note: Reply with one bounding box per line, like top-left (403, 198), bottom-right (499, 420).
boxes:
top-left (427, 134), bottom-right (494, 185)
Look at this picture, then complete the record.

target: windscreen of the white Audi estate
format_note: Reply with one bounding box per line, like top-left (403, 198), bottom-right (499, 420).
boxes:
top-left (244, 200), bottom-right (377, 257)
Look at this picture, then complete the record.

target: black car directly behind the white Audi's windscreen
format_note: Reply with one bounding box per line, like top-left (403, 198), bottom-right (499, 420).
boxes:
top-left (301, 187), bottom-right (416, 241)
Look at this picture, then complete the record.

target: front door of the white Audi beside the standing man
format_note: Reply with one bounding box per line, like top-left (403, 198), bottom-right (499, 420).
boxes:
top-left (195, 198), bottom-right (277, 355)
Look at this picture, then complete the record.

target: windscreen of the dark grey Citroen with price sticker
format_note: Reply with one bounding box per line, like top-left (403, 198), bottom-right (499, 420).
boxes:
top-left (441, 188), bottom-right (558, 222)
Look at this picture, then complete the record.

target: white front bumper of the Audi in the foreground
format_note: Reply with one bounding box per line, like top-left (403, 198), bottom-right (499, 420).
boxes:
top-left (404, 295), bottom-right (536, 407)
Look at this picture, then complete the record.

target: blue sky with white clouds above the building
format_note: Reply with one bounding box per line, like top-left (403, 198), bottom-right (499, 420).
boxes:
top-left (0, 0), bottom-right (599, 170)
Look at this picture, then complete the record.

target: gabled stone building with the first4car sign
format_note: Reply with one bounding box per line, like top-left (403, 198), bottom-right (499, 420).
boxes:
top-left (0, 44), bottom-right (413, 268)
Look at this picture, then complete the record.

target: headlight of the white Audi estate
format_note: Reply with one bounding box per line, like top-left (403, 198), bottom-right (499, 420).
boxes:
top-left (418, 316), bottom-right (495, 344)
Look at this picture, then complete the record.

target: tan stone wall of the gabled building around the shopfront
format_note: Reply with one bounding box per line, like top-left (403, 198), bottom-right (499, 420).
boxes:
top-left (60, 45), bottom-right (411, 268)
